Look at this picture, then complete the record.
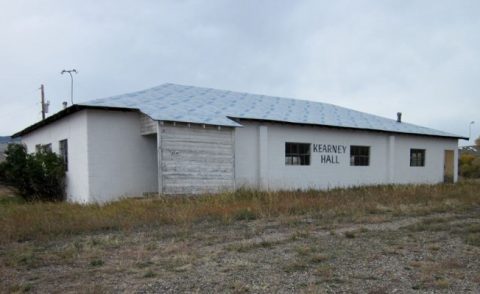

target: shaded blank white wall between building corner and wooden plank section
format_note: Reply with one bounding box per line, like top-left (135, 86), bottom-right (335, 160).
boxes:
top-left (87, 109), bottom-right (158, 202)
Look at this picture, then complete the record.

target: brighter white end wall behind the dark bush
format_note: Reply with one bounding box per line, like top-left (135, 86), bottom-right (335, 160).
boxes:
top-left (22, 111), bottom-right (89, 202)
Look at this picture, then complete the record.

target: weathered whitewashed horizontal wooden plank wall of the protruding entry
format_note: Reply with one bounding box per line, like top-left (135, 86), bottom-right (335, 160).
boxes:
top-left (161, 125), bottom-right (235, 194)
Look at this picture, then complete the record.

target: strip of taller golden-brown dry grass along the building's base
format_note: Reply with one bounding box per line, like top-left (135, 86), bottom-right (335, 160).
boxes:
top-left (0, 181), bottom-right (480, 243)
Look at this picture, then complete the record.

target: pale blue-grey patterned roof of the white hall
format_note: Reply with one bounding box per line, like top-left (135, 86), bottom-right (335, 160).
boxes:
top-left (79, 84), bottom-right (462, 138)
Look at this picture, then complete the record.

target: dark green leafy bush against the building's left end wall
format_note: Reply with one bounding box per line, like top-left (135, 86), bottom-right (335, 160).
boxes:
top-left (0, 144), bottom-right (65, 201)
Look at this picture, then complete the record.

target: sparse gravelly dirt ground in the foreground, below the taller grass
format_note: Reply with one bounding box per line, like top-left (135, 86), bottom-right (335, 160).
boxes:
top-left (0, 210), bottom-right (480, 293)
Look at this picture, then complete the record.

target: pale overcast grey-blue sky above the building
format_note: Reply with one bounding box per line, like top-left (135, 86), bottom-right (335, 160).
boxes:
top-left (0, 0), bottom-right (480, 145)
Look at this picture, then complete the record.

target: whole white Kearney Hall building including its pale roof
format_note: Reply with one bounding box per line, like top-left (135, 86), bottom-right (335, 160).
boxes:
top-left (14, 84), bottom-right (462, 202)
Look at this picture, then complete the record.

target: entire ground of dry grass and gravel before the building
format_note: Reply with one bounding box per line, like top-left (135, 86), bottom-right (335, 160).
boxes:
top-left (0, 181), bottom-right (480, 293)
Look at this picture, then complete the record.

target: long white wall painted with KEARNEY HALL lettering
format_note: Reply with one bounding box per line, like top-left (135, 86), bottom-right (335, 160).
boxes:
top-left (235, 121), bottom-right (458, 190)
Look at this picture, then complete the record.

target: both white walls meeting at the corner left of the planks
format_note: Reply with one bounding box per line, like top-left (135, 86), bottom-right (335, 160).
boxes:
top-left (22, 109), bottom-right (158, 203)
